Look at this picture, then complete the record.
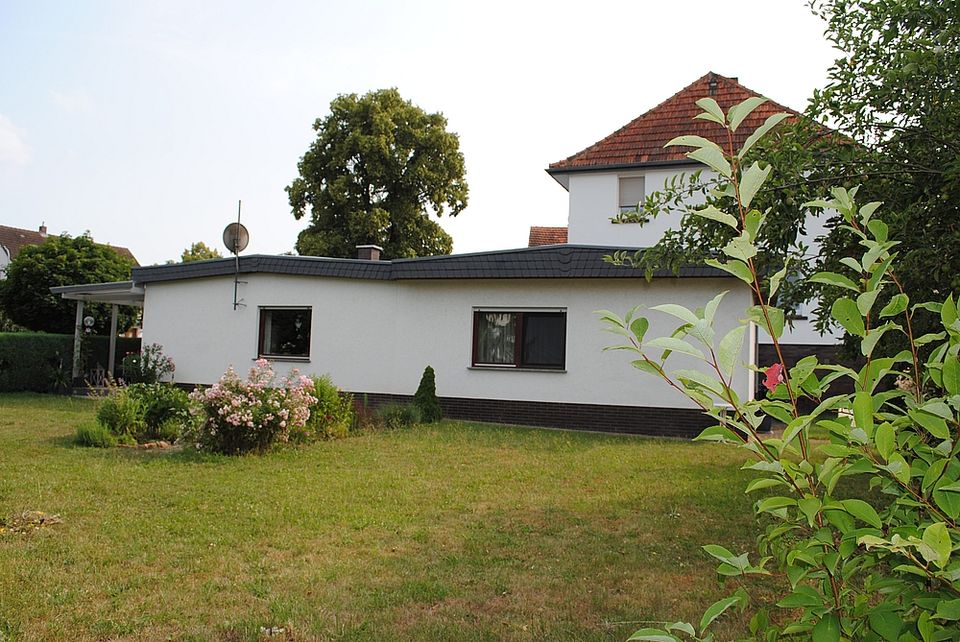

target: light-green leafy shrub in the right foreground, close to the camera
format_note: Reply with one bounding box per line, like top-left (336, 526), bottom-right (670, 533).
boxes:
top-left (600, 98), bottom-right (960, 642)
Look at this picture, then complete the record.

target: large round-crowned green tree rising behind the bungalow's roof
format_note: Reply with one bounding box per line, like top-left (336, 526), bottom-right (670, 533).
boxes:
top-left (286, 89), bottom-right (467, 258)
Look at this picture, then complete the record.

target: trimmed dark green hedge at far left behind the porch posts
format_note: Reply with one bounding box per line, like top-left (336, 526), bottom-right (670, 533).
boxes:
top-left (0, 332), bottom-right (140, 392)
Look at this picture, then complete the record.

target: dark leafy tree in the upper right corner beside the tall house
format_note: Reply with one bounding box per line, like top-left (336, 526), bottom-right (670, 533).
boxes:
top-left (632, 0), bottom-right (960, 336)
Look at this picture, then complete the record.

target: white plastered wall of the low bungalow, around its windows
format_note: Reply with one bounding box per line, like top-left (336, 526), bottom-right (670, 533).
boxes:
top-left (143, 273), bottom-right (752, 408)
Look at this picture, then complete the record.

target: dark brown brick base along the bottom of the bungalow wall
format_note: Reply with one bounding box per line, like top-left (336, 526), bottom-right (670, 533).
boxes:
top-left (353, 392), bottom-right (714, 438)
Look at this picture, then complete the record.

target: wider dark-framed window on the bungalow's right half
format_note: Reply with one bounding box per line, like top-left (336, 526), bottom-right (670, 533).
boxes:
top-left (473, 310), bottom-right (567, 370)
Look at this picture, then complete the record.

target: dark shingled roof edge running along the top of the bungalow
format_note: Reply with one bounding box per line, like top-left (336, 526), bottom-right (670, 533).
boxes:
top-left (133, 245), bottom-right (730, 285)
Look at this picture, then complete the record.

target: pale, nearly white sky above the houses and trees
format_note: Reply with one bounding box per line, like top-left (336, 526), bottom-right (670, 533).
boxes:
top-left (0, 0), bottom-right (835, 265)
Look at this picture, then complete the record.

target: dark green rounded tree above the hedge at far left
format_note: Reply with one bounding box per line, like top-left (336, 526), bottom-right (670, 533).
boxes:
top-left (0, 235), bottom-right (137, 334)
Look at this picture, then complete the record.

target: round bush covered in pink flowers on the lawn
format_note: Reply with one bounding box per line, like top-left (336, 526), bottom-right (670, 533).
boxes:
top-left (184, 359), bottom-right (316, 454)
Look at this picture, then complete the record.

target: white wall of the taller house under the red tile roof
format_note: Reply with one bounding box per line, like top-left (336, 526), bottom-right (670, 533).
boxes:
top-left (558, 165), bottom-right (842, 345)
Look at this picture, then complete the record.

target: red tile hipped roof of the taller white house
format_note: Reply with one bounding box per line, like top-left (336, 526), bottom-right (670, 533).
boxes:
top-left (547, 72), bottom-right (799, 174)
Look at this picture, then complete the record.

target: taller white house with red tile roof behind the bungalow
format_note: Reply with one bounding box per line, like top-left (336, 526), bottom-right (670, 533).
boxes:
top-left (530, 72), bottom-right (839, 345)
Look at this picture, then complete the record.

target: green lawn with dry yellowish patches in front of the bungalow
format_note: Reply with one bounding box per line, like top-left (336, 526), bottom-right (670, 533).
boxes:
top-left (0, 395), bottom-right (757, 641)
